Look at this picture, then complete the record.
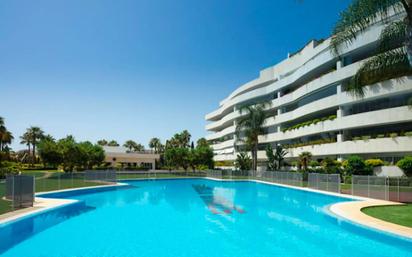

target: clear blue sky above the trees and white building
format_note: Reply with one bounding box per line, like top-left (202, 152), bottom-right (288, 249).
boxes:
top-left (0, 0), bottom-right (350, 150)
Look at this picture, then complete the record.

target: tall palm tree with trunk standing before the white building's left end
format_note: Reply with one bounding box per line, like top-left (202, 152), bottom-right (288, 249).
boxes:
top-left (236, 103), bottom-right (267, 170)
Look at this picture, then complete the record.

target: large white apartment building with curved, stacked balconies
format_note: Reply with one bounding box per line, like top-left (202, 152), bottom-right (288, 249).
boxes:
top-left (205, 11), bottom-right (412, 167)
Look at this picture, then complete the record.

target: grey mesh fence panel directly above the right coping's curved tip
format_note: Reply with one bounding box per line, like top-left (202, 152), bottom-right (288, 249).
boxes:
top-left (308, 173), bottom-right (340, 193)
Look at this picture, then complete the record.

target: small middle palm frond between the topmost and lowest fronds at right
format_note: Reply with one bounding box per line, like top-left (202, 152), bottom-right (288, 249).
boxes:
top-left (379, 21), bottom-right (407, 52)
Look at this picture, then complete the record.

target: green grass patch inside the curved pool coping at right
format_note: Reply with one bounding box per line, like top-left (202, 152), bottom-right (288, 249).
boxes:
top-left (362, 204), bottom-right (412, 228)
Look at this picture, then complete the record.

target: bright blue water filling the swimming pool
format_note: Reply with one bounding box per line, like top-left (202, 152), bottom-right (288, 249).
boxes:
top-left (0, 179), bottom-right (412, 257)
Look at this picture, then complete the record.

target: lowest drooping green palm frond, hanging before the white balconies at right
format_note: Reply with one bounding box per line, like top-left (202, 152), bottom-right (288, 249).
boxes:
top-left (347, 48), bottom-right (412, 97)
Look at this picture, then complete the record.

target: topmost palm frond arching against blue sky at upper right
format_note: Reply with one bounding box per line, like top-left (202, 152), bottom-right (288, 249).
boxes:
top-left (331, 0), bottom-right (404, 56)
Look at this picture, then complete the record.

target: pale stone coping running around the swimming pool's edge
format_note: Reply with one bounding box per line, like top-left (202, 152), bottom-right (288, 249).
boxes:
top-left (0, 177), bottom-right (412, 239)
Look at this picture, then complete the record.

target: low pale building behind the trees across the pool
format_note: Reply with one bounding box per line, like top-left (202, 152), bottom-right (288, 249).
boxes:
top-left (103, 146), bottom-right (160, 170)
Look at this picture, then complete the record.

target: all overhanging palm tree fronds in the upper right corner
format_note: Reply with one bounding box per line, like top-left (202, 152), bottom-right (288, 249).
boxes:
top-left (331, 0), bottom-right (412, 97)
